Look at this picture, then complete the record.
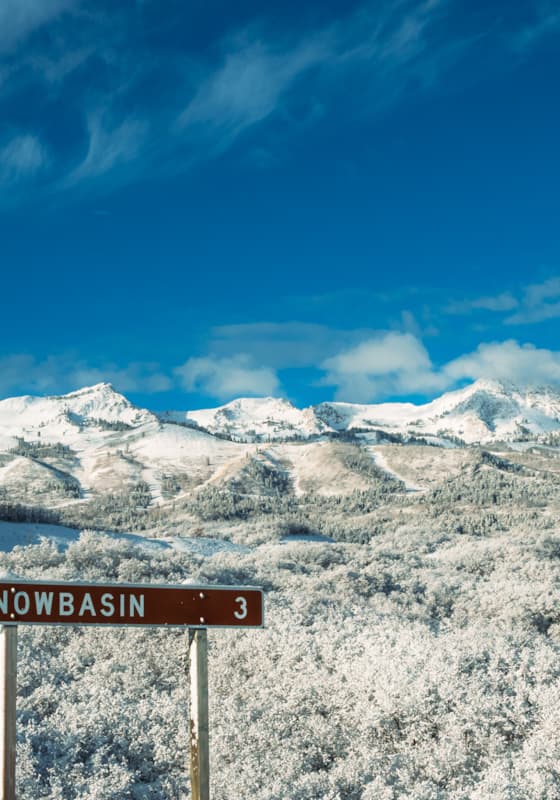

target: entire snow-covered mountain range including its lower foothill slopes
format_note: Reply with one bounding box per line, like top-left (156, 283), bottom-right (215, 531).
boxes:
top-left (0, 381), bottom-right (560, 507)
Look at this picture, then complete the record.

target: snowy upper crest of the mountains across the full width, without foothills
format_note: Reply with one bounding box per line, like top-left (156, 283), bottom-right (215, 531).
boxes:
top-left (0, 378), bottom-right (560, 444)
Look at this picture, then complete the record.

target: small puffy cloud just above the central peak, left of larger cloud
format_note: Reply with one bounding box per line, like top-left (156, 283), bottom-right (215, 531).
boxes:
top-left (174, 354), bottom-right (280, 400)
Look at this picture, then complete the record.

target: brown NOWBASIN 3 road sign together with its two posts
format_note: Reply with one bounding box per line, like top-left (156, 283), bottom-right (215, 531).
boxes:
top-left (0, 580), bottom-right (264, 800)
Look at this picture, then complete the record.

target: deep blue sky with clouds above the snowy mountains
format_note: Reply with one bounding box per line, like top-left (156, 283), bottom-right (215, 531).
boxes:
top-left (0, 0), bottom-right (560, 409)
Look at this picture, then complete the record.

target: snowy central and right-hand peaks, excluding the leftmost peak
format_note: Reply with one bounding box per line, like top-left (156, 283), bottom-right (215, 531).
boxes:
top-left (160, 380), bottom-right (560, 444)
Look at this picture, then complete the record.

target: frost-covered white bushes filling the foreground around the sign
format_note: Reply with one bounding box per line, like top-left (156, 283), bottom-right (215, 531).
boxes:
top-left (0, 509), bottom-right (560, 800)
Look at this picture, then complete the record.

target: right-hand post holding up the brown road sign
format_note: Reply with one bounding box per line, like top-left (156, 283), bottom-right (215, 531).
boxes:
top-left (189, 629), bottom-right (210, 800)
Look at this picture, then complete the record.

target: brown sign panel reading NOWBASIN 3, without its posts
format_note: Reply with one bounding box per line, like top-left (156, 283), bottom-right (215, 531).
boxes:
top-left (0, 581), bottom-right (264, 628)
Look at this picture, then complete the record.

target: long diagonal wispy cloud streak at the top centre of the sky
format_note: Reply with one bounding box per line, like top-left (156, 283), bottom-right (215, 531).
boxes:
top-left (174, 0), bottom-right (456, 157)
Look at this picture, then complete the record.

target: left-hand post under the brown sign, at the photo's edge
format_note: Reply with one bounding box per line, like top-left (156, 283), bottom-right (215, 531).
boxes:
top-left (0, 625), bottom-right (17, 800)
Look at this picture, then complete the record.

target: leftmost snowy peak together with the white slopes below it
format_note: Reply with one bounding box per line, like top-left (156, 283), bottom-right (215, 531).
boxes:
top-left (0, 383), bottom-right (243, 506)
